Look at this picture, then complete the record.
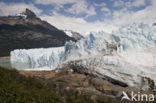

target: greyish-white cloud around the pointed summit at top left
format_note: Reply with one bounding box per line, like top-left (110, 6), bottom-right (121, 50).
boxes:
top-left (0, 2), bottom-right (42, 16)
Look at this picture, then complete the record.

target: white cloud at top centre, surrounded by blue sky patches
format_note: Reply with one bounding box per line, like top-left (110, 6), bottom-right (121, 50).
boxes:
top-left (35, 0), bottom-right (96, 16)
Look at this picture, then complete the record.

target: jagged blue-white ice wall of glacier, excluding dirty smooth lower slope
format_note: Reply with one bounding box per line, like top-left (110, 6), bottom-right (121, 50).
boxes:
top-left (11, 23), bottom-right (156, 69)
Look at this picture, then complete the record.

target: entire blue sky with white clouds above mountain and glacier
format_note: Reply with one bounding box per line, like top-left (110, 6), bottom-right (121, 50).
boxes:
top-left (0, 0), bottom-right (156, 33)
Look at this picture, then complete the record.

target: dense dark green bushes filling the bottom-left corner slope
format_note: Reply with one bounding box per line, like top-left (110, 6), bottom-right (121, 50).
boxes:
top-left (0, 68), bottom-right (63, 103)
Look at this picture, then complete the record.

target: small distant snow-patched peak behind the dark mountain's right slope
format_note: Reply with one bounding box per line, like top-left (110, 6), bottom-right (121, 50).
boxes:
top-left (63, 30), bottom-right (84, 40)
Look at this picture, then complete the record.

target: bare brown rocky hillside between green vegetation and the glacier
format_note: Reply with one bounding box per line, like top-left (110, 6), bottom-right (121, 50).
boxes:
top-left (19, 67), bottom-right (155, 103)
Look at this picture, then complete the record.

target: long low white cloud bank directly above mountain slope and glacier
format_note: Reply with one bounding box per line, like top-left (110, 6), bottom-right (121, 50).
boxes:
top-left (42, 0), bottom-right (156, 32)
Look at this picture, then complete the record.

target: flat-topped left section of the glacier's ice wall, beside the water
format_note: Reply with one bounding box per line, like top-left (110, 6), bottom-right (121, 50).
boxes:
top-left (10, 47), bottom-right (64, 70)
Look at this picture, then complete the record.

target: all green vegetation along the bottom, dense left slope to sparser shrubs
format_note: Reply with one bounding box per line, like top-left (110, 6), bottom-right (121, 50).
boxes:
top-left (0, 67), bottom-right (113, 103)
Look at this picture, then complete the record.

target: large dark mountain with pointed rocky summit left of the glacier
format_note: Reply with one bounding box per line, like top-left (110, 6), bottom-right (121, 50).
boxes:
top-left (0, 9), bottom-right (75, 56)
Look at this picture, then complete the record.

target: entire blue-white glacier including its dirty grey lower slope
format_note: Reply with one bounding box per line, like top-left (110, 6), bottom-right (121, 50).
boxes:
top-left (11, 23), bottom-right (156, 89)
